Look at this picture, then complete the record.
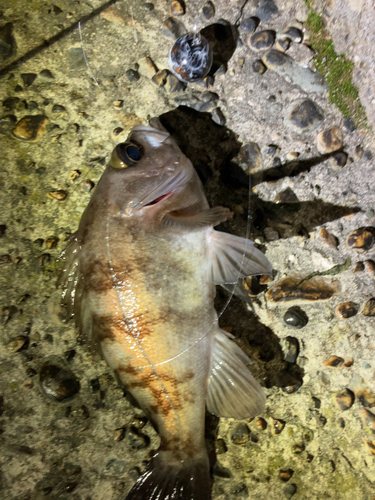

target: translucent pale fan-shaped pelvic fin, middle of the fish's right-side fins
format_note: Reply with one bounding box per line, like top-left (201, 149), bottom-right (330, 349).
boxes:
top-left (209, 230), bottom-right (272, 285)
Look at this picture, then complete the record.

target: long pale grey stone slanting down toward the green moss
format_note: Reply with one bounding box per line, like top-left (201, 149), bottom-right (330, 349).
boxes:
top-left (262, 49), bottom-right (327, 93)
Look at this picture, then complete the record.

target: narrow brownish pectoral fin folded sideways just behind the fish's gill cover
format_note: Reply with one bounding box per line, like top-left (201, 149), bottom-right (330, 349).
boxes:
top-left (162, 207), bottom-right (233, 229)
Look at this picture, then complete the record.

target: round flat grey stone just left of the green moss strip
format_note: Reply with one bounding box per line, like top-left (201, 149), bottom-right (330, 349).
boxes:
top-left (284, 99), bottom-right (324, 133)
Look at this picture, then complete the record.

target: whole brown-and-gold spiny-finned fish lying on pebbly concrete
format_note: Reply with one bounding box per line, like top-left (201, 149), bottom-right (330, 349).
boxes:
top-left (58, 119), bottom-right (272, 500)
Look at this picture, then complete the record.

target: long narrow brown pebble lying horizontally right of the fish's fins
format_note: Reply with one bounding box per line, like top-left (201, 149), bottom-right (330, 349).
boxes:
top-left (266, 276), bottom-right (340, 303)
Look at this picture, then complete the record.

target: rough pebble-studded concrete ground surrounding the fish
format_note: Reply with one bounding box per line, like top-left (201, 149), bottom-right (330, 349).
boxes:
top-left (0, 0), bottom-right (375, 500)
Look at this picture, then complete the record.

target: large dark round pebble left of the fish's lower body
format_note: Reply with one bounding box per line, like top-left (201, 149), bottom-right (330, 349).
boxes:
top-left (39, 360), bottom-right (80, 402)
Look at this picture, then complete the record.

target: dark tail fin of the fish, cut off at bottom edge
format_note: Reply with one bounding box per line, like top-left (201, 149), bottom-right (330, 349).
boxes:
top-left (126, 452), bottom-right (211, 500)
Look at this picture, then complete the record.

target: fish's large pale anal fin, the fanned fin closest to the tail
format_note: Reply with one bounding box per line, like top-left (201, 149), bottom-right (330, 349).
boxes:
top-left (207, 330), bottom-right (266, 420)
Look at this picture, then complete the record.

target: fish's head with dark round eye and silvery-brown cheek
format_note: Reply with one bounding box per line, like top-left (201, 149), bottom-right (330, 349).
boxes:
top-left (106, 118), bottom-right (196, 216)
